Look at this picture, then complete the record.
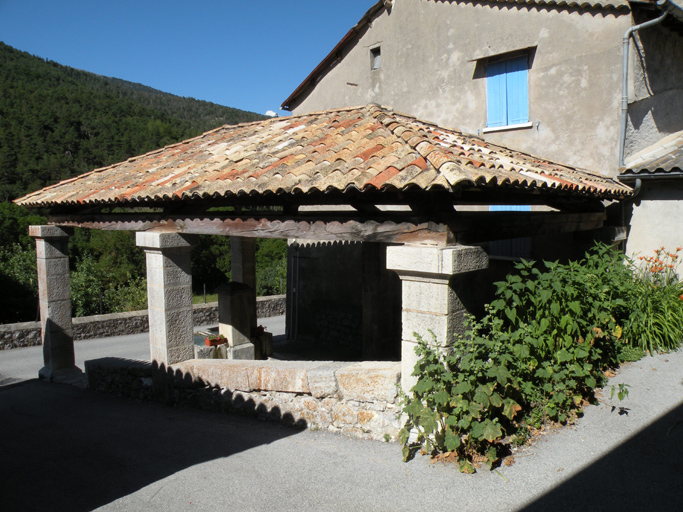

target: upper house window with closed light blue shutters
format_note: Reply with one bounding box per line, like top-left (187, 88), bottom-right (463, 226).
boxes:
top-left (486, 55), bottom-right (529, 128)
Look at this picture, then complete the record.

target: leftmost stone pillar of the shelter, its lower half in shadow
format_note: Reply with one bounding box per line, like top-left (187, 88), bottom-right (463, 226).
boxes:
top-left (29, 226), bottom-right (82, 382)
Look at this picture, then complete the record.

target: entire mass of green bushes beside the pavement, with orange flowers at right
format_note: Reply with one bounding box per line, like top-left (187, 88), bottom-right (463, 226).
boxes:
top-left (400, 244), bottom-right (683, 472)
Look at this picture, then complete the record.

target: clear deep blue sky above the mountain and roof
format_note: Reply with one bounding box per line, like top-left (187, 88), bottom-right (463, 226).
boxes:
top-left (0, 0), bottom-right (375, 114)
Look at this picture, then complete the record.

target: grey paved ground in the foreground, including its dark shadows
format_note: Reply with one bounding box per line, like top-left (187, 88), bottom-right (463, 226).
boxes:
top-left (0, 330), bottom-right (683, 512)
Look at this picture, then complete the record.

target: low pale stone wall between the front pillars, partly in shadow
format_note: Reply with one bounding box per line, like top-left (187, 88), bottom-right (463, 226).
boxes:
top-left (86, 358), bottom-right (401, 440)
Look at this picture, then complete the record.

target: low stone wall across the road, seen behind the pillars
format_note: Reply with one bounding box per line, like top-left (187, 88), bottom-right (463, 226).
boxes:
top-left (0, 295), bottom-right (286, 350)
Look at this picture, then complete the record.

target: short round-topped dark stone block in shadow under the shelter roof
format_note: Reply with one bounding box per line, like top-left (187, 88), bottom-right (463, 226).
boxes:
top-left (217, 282), bottom-right (256, 359)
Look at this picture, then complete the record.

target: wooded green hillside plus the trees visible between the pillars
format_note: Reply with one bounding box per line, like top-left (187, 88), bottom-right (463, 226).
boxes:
top-left (0, 42), bottom-right (286, 323)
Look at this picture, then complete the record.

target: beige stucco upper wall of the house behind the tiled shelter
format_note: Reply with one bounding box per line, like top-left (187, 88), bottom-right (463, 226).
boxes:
top-left (294, 0), bottom-right (631, 175)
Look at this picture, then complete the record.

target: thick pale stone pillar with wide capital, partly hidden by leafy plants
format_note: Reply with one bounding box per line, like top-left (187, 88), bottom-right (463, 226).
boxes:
top-left (387, 246), bottom-right (488, 392)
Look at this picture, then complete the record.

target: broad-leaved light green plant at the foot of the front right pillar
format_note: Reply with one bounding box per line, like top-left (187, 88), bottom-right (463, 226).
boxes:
top-left (399, 332), bottom-right (521, 473)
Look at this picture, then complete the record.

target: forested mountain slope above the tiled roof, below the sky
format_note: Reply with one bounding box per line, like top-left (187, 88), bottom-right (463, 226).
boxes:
top-left (0, 42), bottom-right (265, 201)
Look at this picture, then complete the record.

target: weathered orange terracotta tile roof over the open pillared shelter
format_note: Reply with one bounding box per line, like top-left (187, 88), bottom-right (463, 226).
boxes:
top-left (16, 105), bottom-right (631, 207)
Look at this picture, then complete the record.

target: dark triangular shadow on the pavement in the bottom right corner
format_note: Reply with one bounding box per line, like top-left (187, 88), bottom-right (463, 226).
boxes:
top-left (522, 405), bottom-right (683, 512)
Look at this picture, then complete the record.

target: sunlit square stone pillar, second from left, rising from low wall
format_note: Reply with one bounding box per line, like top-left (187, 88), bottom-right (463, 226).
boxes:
top-left (136, 231), bottom-right (195, 366)
